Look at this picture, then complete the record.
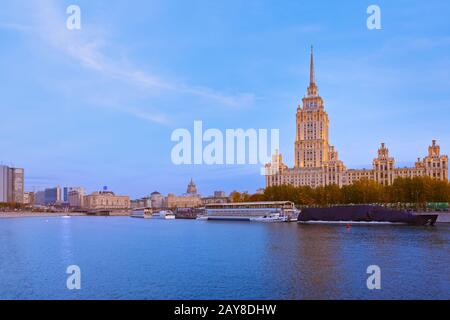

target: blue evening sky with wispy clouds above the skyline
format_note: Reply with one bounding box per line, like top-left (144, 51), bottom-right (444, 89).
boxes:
top-left (0, 0), bottom-right (450, 198)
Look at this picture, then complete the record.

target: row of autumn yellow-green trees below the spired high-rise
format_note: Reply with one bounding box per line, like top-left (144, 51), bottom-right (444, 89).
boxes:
top-left (231, 177), bottom-right (450, 206)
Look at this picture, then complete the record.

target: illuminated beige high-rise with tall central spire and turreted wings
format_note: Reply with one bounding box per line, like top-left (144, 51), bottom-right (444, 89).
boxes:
top-left (266, 48), bottom-right (448, 188)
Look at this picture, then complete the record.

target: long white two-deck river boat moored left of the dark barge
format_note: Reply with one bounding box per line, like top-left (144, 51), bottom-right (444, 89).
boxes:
top-left (198, 201), bottom-right (299, 222)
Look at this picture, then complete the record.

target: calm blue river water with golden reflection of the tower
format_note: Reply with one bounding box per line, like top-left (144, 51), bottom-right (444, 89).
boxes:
top-left (0, 217), bottom-right (450, 299)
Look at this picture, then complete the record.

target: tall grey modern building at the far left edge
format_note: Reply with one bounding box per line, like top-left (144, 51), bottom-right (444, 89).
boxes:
top-left (0, 165), bottom-right (25, 203)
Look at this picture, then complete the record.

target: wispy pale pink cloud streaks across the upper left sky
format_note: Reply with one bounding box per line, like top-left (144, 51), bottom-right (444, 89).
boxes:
top-left (7, 0), bottom-right (254, 123)
